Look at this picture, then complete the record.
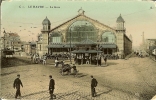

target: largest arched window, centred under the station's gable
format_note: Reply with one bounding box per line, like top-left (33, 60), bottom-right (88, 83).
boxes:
top-left (66, 21), bottom-right (97, 42)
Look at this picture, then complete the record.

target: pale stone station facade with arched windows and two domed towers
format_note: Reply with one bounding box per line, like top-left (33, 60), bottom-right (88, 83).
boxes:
top-left (37, 9), bottom-right (132, 57)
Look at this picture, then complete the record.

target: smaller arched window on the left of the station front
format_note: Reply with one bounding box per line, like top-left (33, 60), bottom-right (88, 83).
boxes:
top-left (50, 32), bottom-right (62, 43)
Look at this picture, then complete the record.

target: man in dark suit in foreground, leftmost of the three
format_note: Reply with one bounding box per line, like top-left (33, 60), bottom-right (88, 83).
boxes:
top-left (13, 74), bottom-right (23, 98)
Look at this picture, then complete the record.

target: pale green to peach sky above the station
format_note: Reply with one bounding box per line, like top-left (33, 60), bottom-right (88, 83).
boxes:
top-left (1, 0), bottom-right (156, 46)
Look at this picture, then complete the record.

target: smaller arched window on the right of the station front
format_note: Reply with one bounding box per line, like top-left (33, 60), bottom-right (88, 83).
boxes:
top-left (102, 31), bottom-right (116, 43)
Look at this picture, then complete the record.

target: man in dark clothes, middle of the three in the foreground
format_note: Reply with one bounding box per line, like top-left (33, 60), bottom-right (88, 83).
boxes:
top-left (49, 75), bottom-right (56, 99)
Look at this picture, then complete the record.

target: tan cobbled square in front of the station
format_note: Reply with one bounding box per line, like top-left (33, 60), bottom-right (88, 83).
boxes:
top-left (1, 56), bottom-right (156, 100)
